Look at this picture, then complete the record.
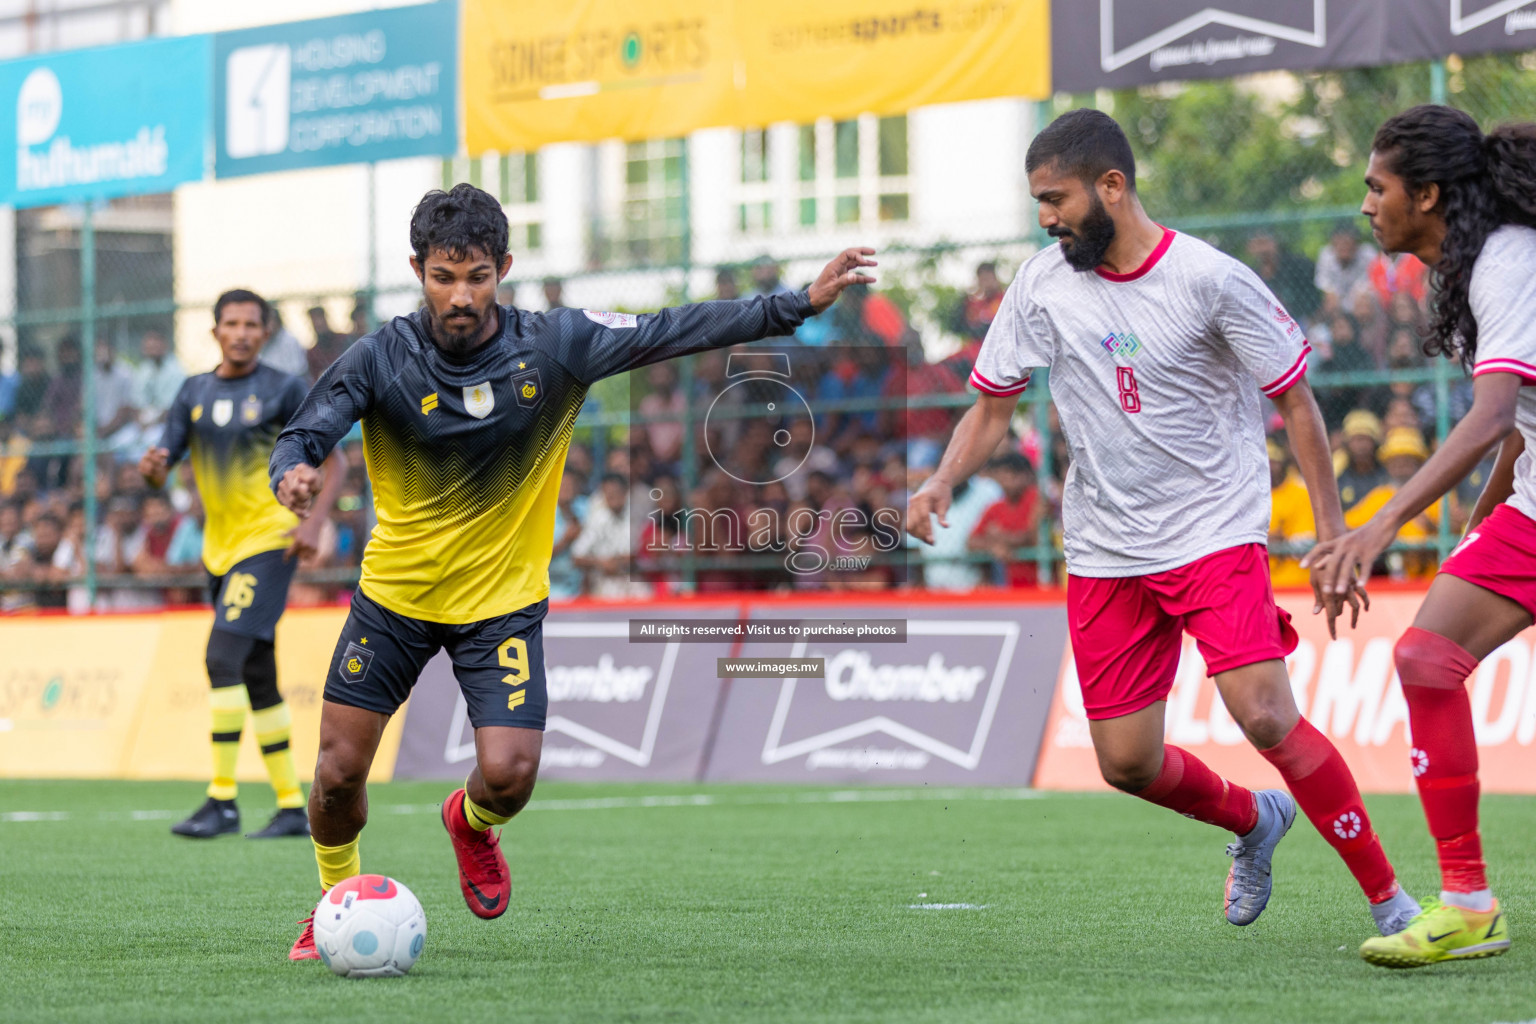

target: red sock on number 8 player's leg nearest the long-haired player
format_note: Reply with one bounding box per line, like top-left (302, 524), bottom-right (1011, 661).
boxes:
top-left (1260, 718), bottom-right (1398, 903)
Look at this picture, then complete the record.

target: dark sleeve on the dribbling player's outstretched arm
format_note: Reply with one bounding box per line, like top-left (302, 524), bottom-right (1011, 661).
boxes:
top-left (561, 292), bottom-right (816, 384)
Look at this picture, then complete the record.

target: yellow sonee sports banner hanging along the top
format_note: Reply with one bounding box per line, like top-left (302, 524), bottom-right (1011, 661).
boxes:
top-left (462, 0), bottom-right (1051, 155)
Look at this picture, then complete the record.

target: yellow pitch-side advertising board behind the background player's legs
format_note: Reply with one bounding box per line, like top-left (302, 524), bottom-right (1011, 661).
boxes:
top-left (0, 608), bottom-right (406, 783)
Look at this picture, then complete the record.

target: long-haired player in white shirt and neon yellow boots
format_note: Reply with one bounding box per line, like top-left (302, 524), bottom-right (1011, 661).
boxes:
top-left (1306, 106), bottom-right (1536, 967)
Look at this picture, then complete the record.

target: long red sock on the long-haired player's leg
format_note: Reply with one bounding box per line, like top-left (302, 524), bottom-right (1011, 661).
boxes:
top-left (1393, 626), bottom-right (1488, 892)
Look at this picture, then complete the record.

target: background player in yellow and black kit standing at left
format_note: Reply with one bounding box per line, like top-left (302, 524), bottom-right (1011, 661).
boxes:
top-left (138, 290), bottom-right (344, 838)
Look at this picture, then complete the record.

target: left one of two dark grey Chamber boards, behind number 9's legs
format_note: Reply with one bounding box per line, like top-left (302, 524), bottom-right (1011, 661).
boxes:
top-left (395, 606), bottom-right (736, 781)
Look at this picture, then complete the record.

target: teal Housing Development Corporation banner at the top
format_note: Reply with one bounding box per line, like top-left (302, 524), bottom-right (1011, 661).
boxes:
top-left (214, 0), bottom-right (459, 178)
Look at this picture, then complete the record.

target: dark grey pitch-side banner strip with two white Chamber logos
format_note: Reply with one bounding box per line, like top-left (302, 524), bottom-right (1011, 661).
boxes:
top-left (395, 602), bottom-right (1066, 786)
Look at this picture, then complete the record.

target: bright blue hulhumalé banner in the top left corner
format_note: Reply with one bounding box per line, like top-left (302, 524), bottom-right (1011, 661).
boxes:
top-left (0, 35), bottom-right (212, 206)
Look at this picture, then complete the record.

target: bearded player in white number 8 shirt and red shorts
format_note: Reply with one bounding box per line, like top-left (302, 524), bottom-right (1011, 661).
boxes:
top-left (908, 111), bottom-right (1419, 935)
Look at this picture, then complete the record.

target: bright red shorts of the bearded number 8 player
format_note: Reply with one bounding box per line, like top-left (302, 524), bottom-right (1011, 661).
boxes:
top-left (1066, 543), bottom-right (1296, 718)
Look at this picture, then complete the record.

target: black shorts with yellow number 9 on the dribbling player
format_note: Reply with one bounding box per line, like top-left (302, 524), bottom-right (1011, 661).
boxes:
top-left (326, 590), bottom-right (550, 731)
